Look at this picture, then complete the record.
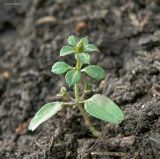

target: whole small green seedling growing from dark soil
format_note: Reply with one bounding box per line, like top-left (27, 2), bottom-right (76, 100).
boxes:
top-left (29, 35), bottom-right (124, 137)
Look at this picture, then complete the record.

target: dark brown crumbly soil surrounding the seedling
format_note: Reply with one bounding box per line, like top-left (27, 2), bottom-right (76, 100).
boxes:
top-left (0, 0), bottom-right (160, 159)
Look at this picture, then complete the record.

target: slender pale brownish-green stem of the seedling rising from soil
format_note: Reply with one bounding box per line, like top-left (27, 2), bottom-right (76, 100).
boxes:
top-left (74, 54), bottom-right (100, 137)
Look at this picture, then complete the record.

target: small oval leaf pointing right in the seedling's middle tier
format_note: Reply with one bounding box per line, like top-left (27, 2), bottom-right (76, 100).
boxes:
top-left (81, 65), bottom-right (106, 80)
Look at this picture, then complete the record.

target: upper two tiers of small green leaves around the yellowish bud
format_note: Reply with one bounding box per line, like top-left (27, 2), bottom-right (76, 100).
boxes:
top-left (51, 35), bottom-right (105, 87)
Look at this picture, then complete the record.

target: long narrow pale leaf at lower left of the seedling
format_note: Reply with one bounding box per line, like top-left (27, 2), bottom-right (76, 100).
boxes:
top-left (28, 102), bottom-right (63, 131)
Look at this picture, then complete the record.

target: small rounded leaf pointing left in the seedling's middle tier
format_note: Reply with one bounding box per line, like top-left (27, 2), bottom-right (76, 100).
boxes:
top-left (51, 62), bottom-right (72, 74)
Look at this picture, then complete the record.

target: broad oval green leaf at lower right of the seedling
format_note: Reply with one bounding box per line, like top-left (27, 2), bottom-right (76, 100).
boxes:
top-left (84, 94), bottom-right (124, 124)
